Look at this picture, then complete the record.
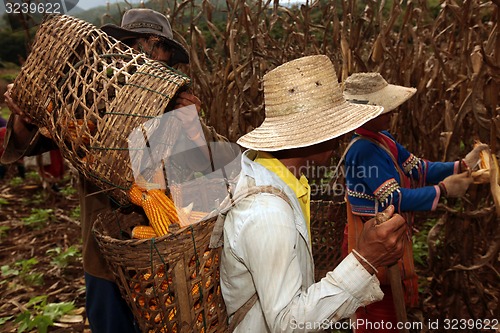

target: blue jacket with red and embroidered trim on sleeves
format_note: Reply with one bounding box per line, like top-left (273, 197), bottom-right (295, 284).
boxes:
top-left (344, 129), bottom-right (459, 216)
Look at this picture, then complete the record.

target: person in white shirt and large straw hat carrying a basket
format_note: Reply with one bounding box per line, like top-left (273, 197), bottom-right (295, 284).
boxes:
top-left (221, 55), bottom-right (405, 332)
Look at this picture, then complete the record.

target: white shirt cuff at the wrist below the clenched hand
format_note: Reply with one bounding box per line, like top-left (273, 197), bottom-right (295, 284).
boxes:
top-left (328, 253), bottom-right (384, 305)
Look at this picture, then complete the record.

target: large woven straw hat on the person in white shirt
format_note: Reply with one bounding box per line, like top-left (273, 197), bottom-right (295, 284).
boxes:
top-left (238, 55), bottom-right (383, 151)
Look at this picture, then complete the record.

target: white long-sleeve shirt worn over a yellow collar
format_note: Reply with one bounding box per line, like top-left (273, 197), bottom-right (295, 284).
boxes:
top-left (221, 151), bottom-right (383, 333)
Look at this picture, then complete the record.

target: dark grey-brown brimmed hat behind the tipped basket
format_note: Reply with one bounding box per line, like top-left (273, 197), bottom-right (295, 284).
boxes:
top-left (101, 8), bottom-right (189, 66)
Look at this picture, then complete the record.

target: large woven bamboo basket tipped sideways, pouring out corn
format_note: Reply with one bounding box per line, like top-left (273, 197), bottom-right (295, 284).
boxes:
top-left (12, 15), bottom-right (190, 204)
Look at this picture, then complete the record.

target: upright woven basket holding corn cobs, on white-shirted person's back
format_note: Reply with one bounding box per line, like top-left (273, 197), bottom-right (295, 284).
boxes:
top-left (94, 211), bottom-right (227, 333)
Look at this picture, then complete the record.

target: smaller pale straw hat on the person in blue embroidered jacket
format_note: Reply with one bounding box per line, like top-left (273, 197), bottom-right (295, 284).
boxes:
top-left (344, 73), bottom-right (417, 113)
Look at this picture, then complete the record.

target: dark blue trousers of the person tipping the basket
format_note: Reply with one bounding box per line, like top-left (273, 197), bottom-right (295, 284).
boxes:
top-left (85, 273), bottom-right (141, 333)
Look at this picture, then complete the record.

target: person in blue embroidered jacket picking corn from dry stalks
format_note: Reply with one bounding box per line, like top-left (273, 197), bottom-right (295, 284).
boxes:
top-left (343, 73), bottom-right (487, 332)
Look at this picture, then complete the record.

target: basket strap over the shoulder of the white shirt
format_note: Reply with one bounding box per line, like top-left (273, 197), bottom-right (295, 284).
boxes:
top-left (210, 185), bottom-right (292, 249)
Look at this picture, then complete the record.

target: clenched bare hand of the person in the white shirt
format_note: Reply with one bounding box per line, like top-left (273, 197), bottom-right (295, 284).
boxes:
top-left (356, 206), bottom-right (407, 273)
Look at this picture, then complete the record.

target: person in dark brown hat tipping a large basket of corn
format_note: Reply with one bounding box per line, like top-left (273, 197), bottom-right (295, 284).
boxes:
top-left (1, 8), bottom-right (239, 333)
